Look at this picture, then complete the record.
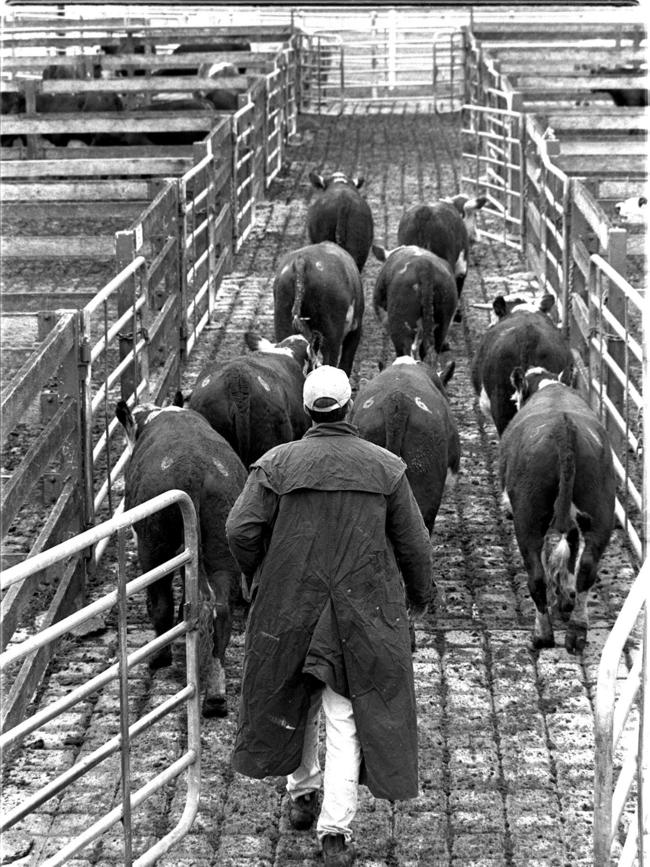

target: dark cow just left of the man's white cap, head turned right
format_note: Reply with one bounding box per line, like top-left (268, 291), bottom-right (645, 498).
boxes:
top-left (189, 333), bottom-right (311, 466)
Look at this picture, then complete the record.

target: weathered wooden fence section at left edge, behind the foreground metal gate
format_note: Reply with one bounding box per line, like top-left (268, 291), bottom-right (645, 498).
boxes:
top-left (0, 311), bottom-right (86, 726)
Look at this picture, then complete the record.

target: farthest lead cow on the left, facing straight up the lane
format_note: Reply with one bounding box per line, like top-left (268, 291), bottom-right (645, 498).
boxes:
top-left (307, 171), bottom-right (373, 271)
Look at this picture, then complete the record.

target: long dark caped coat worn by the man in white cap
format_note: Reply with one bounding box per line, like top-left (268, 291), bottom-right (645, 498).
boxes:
top-left (226, 422), bottom-right (431, 800)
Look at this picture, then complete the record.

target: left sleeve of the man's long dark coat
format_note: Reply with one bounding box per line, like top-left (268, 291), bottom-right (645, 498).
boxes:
top-left (226, 469), bottom-right (278, 578)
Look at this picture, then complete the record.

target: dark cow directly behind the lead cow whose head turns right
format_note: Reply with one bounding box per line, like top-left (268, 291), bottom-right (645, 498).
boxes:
top-left (372, 244), bottom-right (458, 361)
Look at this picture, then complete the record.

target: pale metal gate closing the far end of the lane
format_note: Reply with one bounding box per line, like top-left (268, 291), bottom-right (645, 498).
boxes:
top-left (300, 21), bottom-right (465, 114)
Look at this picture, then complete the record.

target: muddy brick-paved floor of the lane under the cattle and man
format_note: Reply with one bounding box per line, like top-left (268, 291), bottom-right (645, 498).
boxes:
top-left (3, 106), bottom-right (635, 867)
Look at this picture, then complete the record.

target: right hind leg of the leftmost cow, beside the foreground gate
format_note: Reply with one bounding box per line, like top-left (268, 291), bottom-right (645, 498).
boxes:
top-left (199, 571), bottom-right (239, 717)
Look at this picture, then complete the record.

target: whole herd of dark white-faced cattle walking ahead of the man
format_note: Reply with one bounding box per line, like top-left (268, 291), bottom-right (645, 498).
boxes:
top-left (116, 171), bottom-right (615, 716)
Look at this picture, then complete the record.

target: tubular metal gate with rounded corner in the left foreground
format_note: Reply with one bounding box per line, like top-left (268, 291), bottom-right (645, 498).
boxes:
top-left (0, 491), bottom-right (201, 867)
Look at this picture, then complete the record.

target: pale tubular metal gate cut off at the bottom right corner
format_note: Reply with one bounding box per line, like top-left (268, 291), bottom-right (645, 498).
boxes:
top-left (593, 560), bottom-right (650, 867)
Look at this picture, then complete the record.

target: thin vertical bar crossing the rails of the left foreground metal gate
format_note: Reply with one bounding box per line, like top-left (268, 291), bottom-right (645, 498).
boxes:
top-left (117, 529), bottom-right (133, 867)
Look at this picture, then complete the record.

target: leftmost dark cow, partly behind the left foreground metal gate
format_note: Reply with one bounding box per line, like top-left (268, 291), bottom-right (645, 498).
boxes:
top-left (115, 401), bottom-right (246, 716)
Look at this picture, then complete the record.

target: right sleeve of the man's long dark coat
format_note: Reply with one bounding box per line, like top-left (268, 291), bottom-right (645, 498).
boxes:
top-left (386, 475), bottom-right (433, 605)
